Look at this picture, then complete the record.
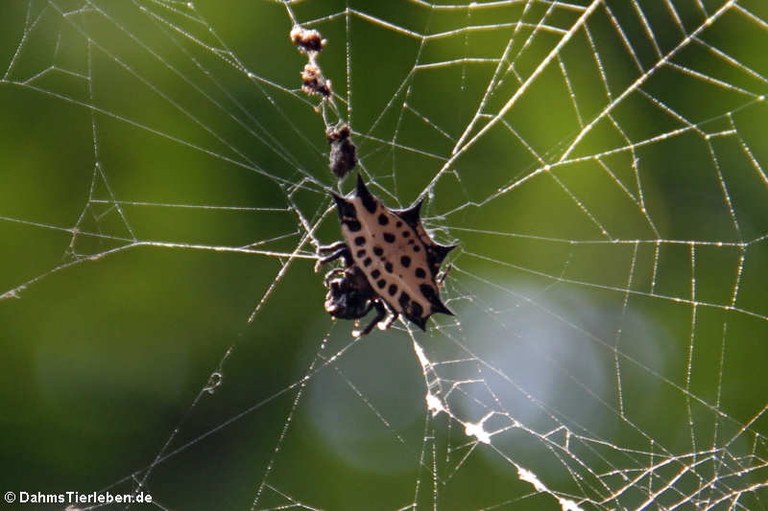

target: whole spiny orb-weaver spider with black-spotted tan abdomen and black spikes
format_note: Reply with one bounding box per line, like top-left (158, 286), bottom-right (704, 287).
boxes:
top-left (318, 175), bottom-right (455, 335)
